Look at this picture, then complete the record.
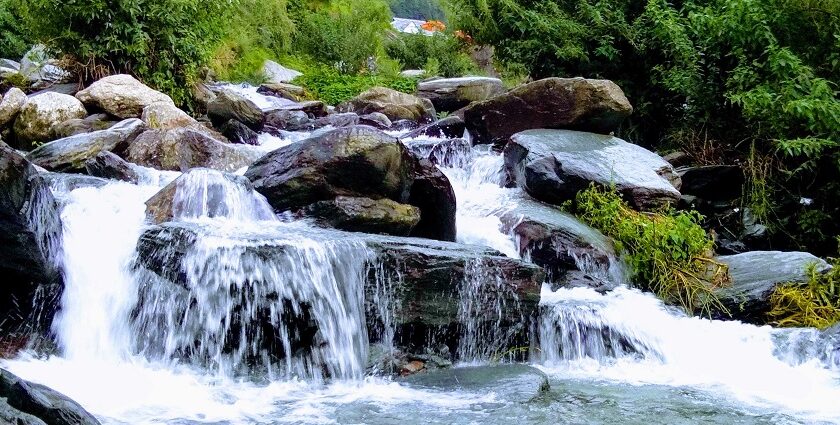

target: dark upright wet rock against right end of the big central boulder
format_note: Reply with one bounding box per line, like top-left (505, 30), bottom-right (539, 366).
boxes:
top-left (408, 159), bottom-right (457, 242)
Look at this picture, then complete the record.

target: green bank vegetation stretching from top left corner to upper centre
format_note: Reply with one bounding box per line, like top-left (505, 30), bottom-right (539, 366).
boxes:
top-left (0, 0), bottom-right (474, 107)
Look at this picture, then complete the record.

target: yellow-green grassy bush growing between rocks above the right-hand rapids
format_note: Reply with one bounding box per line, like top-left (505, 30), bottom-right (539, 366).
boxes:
top-left (568, 185), bottom-right (729, 314)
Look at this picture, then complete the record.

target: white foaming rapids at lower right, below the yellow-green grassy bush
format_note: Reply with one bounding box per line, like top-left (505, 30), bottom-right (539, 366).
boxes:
top-left (540, 287), bottom-right (840, 421)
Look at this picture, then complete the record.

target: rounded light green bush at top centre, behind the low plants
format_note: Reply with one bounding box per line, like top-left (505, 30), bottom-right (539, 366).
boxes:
top-left (294, 0), bottom-right (391, 74)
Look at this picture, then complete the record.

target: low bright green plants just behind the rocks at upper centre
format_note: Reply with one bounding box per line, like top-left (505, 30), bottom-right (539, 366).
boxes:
top-left (293, 65), bottom-right (417, 105)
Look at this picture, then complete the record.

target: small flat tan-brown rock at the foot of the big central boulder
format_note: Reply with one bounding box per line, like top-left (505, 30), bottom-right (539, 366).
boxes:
top-left (305, 196), bottom-right (420, 236)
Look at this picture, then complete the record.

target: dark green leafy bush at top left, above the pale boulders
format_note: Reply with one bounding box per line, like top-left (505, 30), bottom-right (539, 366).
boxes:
top-left (27, 0), bottom-right (233, 104)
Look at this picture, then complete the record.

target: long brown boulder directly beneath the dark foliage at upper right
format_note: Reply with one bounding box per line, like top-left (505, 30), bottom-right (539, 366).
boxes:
top-left (464, 78), bottom-right (633, 143)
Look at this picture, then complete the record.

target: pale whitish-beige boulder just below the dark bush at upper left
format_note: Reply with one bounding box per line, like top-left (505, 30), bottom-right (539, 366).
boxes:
top-left (76, 74), bottom-right (173, 119)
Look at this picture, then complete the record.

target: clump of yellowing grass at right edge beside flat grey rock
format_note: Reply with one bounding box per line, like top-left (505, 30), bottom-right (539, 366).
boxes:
top-left (768, 255), bottom-right (840, 329)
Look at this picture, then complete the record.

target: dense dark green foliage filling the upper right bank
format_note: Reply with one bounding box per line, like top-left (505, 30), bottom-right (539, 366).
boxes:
top-left (450, 0), bottom-right (840, 253)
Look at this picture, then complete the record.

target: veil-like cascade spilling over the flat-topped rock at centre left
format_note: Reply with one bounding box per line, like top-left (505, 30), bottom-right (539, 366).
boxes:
top-left (133, 223), bottom-right (371, 380)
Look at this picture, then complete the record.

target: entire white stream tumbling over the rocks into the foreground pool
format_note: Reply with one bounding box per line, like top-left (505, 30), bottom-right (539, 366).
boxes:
top-left (1, 88), bottom-right (840, 424)
